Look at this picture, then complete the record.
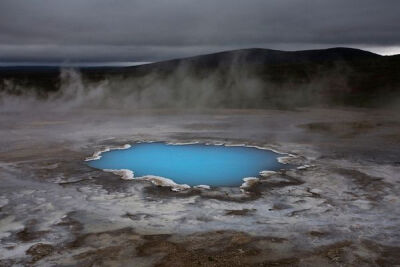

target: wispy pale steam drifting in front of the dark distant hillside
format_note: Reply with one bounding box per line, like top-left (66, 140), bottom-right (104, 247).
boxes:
top-left (0, 58), bottom-right (398, 111)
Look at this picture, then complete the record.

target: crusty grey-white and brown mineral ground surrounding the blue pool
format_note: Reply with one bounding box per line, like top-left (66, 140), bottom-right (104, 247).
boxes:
top-left (0, 109), bottom-right (400, 266)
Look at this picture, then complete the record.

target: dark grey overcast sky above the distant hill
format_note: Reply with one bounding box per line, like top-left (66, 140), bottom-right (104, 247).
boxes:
top-left (0, 0), bottom-right (400, 62)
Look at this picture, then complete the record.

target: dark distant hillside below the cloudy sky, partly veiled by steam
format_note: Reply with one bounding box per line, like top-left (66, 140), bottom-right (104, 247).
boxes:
top-left (0, 48), bottom-right (400, 108)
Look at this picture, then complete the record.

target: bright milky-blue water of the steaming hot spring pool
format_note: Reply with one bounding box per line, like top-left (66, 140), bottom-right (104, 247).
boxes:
top-left (89, 143), bottom-right (285, 186)
